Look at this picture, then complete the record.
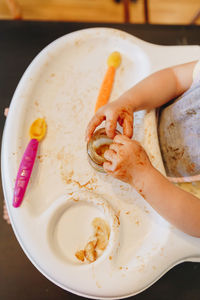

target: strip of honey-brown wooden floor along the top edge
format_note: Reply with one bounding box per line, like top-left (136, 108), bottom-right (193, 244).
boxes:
top-left (0, 0), bottom-right (200, 24)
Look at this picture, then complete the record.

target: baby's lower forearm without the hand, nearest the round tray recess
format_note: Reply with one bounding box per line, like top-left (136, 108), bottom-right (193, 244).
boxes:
top-left (132, 168), bottom-right (200, 237)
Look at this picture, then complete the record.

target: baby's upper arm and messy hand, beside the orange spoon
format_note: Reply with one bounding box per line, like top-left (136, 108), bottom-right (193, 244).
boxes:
top-left (86, 62), bottom-right (196, 140)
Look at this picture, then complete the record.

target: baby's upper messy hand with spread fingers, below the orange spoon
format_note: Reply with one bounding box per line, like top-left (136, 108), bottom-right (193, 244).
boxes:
top-left (86, 99), bottom-right (133, 141)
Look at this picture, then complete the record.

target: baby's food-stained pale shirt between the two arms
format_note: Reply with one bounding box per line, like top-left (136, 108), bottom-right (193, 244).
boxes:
top-left (158, 61), bottom-right (200, 182)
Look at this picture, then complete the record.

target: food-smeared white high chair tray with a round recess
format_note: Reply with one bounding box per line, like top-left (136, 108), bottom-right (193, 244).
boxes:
top-left (2, 28), bottom-right (200, 299)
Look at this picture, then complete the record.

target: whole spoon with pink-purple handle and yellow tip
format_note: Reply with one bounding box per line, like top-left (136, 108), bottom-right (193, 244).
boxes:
top-left (13, 118), bottom-right (47, 207)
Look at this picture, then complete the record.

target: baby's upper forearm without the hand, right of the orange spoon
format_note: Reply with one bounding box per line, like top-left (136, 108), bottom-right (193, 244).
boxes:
top-left (120, 62), bottom-right (196, 111)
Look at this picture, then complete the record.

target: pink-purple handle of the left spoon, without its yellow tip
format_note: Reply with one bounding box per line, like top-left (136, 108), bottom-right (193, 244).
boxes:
top-left (13, 139), bottom-right (39, 207)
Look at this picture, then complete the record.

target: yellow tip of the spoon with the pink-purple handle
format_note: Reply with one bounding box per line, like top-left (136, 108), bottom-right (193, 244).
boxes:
top-left (29, 118), bottom-right (47, 142)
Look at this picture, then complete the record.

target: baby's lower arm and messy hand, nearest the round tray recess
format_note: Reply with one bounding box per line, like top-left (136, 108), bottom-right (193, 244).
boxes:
top-left (104, 135), bottom-right (200, 237)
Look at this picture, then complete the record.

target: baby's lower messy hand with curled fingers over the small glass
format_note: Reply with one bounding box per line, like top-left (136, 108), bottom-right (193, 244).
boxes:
top-left (103, 135), bottom-right (152, 191)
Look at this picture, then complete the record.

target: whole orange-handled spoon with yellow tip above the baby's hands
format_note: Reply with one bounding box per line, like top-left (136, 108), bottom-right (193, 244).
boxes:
top-left (95, 51), bottom-right (121, 112)
